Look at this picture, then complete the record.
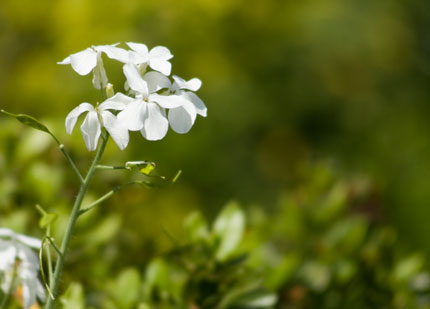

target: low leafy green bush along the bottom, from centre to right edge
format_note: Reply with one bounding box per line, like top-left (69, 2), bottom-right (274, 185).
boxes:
top-left (85, 165), bottom-right (430, 309)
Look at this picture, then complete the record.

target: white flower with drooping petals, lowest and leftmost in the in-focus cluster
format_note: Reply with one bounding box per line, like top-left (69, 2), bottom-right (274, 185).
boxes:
top-left (66, 93), bottom-right (133, 151)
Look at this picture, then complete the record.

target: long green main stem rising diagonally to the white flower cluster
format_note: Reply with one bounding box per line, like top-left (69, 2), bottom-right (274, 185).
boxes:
top-left (45, 132), bottom-right (109, 309)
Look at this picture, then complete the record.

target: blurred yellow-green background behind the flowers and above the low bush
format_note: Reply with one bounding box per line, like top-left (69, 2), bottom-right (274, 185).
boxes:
top-left (0, 0), bottom-right (430, 302)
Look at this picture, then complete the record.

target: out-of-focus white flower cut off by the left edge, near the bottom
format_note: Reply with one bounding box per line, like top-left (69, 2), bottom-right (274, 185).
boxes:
top-left (0, 228), bottom-right (45, 309)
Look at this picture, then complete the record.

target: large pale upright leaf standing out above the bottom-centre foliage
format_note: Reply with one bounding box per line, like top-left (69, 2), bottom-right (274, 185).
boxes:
top-left (212, 202), bottom-right (245, 261)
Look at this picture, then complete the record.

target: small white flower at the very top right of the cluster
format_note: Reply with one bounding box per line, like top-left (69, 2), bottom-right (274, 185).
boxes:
top-left (126, 42), bottom-right (173, 76)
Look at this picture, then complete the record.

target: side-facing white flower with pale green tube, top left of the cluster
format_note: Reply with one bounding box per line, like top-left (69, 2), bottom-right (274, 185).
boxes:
top-left (58, 44), bottom-right (129, 89)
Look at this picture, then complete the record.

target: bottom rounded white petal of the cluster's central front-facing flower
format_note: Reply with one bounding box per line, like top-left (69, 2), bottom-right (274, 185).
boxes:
top-left (140, 103), bottom-right (169, 141)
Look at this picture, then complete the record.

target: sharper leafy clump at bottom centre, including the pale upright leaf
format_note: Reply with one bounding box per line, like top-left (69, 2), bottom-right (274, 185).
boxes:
top-left (108, 203), bottom-right (276, 309)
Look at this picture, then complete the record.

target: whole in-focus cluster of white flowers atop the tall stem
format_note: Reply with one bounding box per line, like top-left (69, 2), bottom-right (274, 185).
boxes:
top-left (59, 43), bottom-right (207, 151)
